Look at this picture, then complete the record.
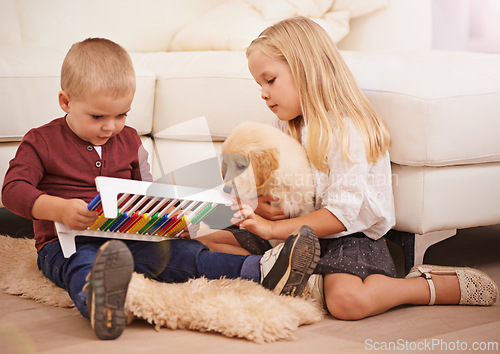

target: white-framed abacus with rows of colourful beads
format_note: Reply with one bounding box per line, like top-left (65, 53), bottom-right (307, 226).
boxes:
top-left (55, 176), bottom-right (233, 258)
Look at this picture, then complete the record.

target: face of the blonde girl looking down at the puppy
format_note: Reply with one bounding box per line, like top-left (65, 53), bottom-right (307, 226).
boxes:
top-left (248, 49), bottom-right (302, 121)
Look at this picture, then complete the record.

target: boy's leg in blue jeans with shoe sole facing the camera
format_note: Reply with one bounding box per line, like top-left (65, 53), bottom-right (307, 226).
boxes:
top-left (38, 238), bottom-right (133, 339)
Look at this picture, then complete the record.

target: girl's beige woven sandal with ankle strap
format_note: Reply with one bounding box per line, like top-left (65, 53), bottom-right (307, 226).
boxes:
top-left (406, 264), bottom-right (498, 306)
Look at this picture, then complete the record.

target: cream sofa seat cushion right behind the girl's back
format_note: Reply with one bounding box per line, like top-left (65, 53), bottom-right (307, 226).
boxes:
top-left (344, 52), bottom-right (500, 166)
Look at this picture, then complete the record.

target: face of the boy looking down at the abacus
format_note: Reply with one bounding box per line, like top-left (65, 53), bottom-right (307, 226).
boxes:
top-left (59, 91), bottom-right (134, 145)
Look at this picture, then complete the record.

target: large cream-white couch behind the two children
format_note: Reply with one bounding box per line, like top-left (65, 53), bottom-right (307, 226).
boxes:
top-left (0, 0), bottom-right (500, 272)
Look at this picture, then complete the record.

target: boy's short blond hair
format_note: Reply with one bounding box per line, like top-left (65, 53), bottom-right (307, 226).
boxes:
top-left (61, 38), bottom-right (135, 100)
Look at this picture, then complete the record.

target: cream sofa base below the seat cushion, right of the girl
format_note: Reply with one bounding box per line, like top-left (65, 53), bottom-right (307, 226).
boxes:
top-left (392, 162), bottom-right (500, 234)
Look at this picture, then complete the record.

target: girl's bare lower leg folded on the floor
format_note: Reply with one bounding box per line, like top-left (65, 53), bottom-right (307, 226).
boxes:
top-left (324, 273), bottom-right (460, 320)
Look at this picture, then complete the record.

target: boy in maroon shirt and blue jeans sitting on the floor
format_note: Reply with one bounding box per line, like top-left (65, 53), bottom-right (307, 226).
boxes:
top-left (2, 38), bottom-right (319, 339)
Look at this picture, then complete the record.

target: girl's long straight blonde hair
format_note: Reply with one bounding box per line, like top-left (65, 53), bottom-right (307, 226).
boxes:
top-left (247, 17), bottom-right (390, 172)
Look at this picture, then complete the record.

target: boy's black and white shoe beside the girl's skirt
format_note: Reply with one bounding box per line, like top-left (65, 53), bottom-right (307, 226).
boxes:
top-left (260, 225), bottom-right (320, 296)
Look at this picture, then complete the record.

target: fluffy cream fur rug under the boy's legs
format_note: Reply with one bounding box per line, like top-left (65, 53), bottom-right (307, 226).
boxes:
top-left (0, 236), bottom-right (323, 343)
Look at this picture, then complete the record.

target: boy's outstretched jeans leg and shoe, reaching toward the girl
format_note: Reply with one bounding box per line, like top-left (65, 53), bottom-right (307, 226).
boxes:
top-left (128, 226), bottom-right (319, 295)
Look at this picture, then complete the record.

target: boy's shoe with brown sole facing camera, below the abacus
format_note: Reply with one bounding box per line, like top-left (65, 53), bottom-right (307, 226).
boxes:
top-left (87, 240), bottom-right (134, 339)
